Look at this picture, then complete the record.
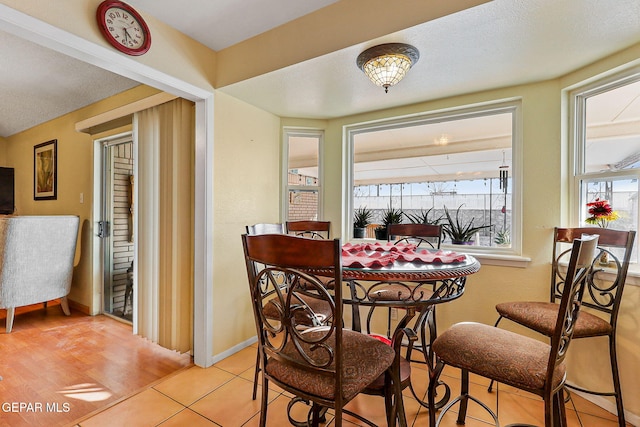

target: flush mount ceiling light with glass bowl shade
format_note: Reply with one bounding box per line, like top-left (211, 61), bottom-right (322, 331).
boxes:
top-left (356, 43), bottom-right (420, 93)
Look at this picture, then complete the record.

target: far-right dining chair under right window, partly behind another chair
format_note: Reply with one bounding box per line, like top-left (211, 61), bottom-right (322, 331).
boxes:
top-left (489, 227), bottom-right (636, 427)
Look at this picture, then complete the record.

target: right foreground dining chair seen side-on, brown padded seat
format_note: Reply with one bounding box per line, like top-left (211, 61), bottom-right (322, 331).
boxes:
top-left (428, 235), bottom-right (598, 427)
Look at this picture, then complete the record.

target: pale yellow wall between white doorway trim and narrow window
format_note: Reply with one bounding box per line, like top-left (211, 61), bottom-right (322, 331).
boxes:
top-left (213, 92), bottom-right (280, 354)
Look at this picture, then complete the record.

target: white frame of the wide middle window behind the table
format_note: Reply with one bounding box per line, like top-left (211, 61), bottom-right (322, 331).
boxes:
top-left (342, 98), bottom-right (523, 256)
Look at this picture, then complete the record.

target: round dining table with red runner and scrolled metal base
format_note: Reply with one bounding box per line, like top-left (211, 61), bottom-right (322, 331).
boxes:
top-left (342, 243), bottom-right (480, 408)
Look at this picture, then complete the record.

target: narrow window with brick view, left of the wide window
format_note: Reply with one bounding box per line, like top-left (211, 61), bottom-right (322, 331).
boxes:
top-left (283, 129), bottom-right (322, 221)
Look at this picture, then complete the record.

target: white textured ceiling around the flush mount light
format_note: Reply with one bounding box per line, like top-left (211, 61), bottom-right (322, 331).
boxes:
top-left (222, 0), bottom-right (640, 118)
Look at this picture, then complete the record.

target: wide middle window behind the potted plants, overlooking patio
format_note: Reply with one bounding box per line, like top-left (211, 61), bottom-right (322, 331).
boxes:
top-left (348, 101), bottom-right (520, 253)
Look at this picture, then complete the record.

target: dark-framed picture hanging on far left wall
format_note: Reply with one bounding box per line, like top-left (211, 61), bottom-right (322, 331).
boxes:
top-left (33, 139), bottom-right (58, 200)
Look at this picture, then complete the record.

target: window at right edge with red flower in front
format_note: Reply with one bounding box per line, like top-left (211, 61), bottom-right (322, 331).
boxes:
top-left (571, 69), bottom-right (640, 261)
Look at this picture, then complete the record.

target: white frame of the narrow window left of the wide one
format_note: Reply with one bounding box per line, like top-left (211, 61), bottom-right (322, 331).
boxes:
top-left (280, 127), bottom-right (324, 222)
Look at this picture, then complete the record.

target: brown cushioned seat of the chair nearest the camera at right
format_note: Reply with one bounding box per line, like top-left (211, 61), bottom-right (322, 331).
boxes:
top-left (433, 322), bottom-right (565, 393)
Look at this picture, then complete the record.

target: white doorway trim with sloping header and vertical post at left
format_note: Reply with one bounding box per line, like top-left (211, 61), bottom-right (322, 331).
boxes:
top-left (0, 4), bottom-right (213, 367)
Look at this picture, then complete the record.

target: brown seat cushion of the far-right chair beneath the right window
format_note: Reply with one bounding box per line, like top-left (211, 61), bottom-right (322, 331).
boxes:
top-left (496, 301), bottom-right (612, 338)
